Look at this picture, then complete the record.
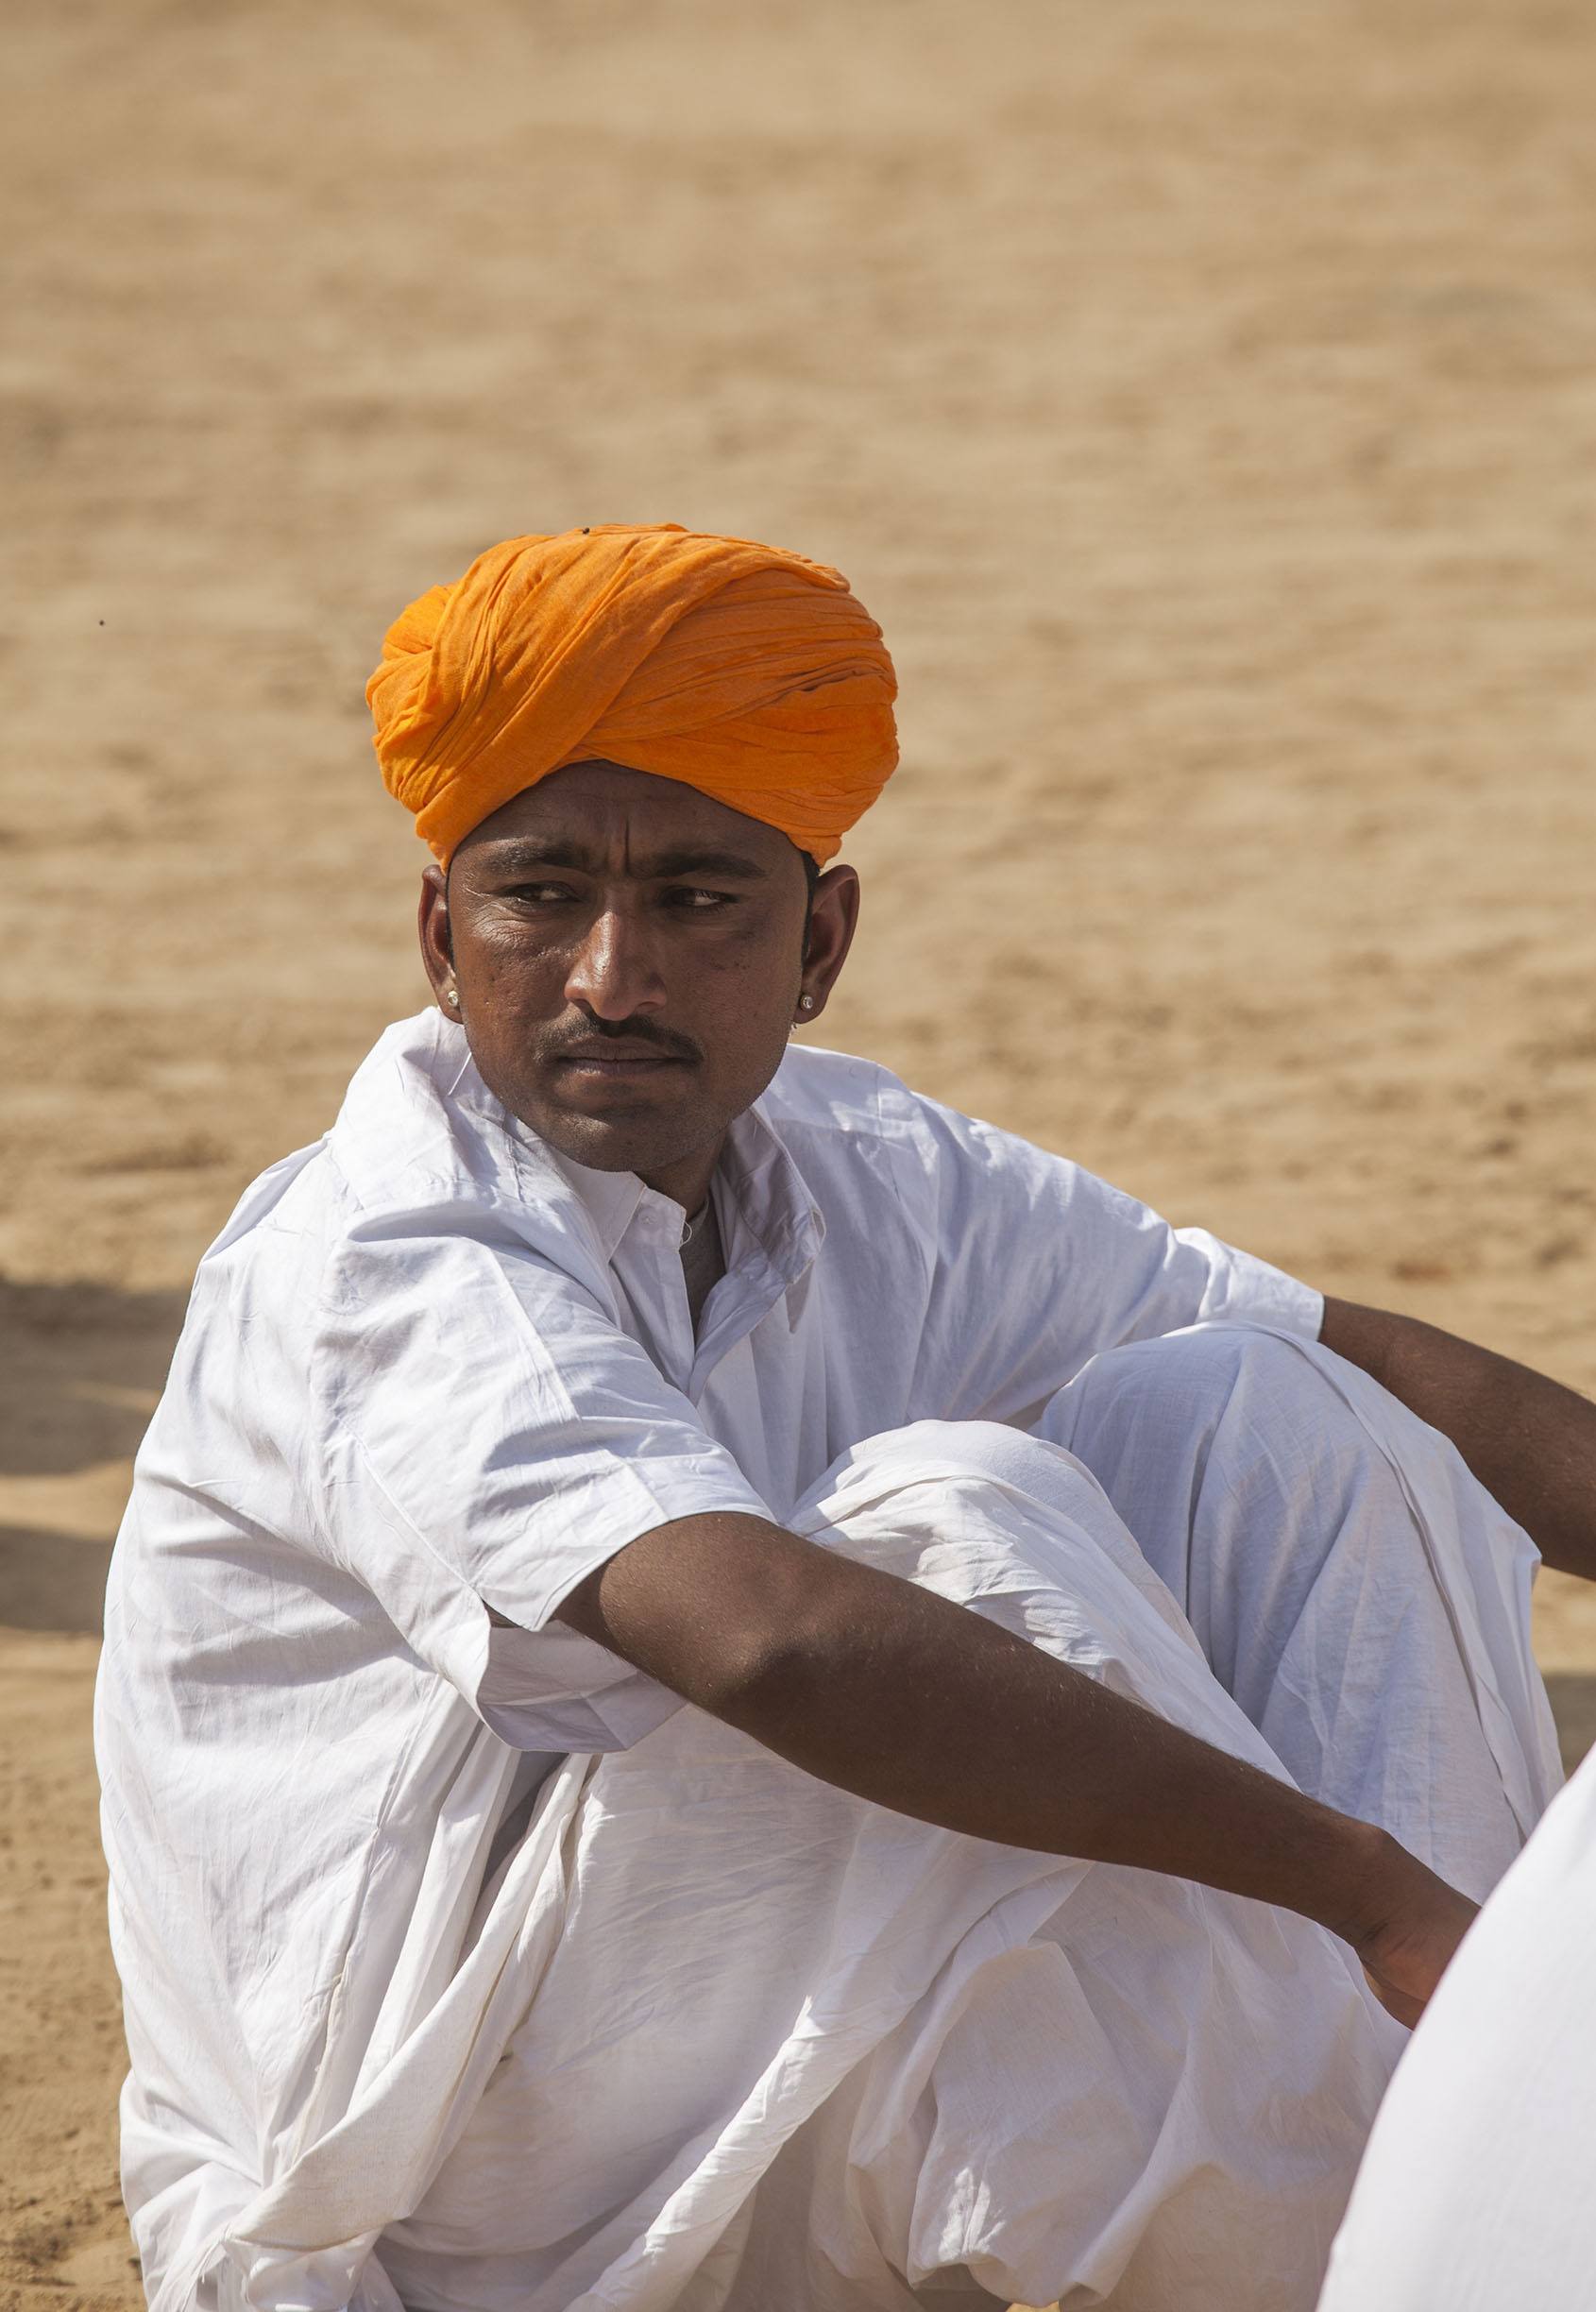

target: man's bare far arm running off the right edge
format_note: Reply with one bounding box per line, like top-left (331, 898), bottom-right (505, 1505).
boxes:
top-left (1318, 1300), bottom-right (1596, 1581)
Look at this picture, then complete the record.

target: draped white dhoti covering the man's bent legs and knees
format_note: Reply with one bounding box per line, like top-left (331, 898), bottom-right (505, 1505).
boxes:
top-left (217, 1327), bottom-right (1556, 2312)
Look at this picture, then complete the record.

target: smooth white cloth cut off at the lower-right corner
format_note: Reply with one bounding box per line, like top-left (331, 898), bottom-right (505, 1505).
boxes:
top-left (1321, 1753), bottom-right (1596, 2312)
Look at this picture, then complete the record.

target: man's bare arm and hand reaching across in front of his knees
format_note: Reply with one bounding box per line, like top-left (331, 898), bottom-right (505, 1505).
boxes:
top-left (562, 1514), bottom-right (1473, 2021)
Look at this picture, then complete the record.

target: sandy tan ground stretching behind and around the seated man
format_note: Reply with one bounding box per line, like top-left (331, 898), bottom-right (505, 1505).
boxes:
top-left (0, 0), bottom-right (1596, 2312)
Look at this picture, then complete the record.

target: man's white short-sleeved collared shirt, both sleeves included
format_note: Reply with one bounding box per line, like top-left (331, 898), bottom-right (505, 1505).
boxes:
top-left (97, 1011), bottom-right (1321, 2312)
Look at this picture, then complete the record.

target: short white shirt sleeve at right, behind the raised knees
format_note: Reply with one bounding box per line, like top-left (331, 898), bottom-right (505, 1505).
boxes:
top-left (916, 1100), bottom-right (1323, 1422)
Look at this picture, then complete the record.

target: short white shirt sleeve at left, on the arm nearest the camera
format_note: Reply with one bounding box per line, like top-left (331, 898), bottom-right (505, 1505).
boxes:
top-left (313, 1212), bottom-right (771, 1750)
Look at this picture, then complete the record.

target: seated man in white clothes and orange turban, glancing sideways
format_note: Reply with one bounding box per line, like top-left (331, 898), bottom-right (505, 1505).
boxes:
top-left (99, 527), bottom-right (1596, 2312)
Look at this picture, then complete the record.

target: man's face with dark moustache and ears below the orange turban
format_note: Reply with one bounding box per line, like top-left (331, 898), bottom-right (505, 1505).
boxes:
top-left (421, 763), bottom-right (858, 1212)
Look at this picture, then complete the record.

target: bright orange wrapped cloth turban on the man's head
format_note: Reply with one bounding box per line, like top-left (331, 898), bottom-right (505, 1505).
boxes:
top-left (365, 522), bottom-right (897, 865)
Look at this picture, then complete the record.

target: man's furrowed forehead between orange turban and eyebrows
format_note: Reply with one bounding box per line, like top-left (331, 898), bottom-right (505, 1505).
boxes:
top-left (456, 763), bottom-right (803, 876)
